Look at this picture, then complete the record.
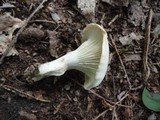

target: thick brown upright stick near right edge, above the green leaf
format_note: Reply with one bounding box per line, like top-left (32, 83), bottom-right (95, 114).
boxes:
top-left (143, 9), bottom-right (153, 82)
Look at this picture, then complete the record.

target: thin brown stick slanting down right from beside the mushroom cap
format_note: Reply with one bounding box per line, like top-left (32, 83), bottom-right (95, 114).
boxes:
top-left (109, 34), bottom-right (131, 89)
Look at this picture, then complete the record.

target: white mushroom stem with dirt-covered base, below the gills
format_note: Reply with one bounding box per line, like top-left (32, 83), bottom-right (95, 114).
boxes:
top-left (32, 51), bottom-right (77, 82)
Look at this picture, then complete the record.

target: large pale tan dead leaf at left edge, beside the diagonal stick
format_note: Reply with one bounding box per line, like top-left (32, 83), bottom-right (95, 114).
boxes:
top-left (0, 14), bottom-right (25, 56)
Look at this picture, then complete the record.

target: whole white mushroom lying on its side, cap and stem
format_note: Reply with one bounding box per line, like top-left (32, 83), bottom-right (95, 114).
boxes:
top-left (29, 23), bottom-right (109, 89)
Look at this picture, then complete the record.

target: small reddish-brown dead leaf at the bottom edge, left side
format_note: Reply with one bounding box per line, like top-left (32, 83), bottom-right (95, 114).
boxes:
top-left (19, 110), bottom-right (37, 120)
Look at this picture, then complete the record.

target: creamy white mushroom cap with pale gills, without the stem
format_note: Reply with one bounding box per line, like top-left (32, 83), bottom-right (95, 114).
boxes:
top-left (73, 23), bottom-right (109, 89)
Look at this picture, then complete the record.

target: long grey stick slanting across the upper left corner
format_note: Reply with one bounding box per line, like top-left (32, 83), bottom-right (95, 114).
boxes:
top-left (0, 0), bottom-right (48, 64)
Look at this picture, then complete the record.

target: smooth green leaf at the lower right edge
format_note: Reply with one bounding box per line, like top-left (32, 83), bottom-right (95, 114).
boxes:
top-left (142, 88), bottom-right (160, 112)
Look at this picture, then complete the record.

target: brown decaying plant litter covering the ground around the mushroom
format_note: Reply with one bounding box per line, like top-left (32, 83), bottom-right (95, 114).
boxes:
top-left (0, 0), bottom-right (160, 120)
